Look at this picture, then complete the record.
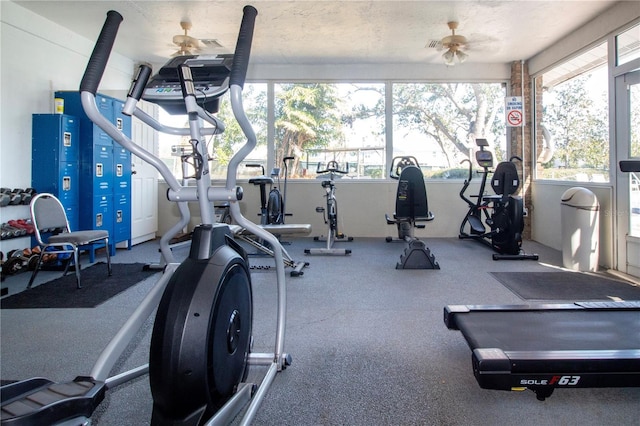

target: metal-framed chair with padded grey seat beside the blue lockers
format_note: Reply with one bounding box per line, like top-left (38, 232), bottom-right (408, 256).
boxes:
top-left (27, 193), bottom-right (111, 289)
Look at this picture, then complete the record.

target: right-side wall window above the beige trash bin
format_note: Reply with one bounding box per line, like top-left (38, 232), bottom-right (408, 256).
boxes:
top-left (535, 43), bottom-right (609, 182)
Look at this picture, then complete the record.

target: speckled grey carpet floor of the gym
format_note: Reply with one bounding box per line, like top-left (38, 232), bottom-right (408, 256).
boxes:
top-left (0, 238), bottom-right (640, 425)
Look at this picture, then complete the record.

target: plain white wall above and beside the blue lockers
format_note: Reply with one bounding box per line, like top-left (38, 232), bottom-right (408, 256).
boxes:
top-left (0, 1), bottom-right (134, 191)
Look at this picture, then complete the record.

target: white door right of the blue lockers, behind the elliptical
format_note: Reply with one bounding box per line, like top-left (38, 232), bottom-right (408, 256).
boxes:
top-left (131, 101), bottom-right (158, 245)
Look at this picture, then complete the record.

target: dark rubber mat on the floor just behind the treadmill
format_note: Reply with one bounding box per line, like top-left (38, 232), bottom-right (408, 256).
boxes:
top-left (491, 272), bottom-right (640, 302)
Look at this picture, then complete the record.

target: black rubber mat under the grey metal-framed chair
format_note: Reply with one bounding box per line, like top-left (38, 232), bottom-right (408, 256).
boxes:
top-left (0, 263), bottom-right (158, 309)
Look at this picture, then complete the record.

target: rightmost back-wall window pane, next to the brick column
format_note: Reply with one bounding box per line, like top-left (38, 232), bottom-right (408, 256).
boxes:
top-left (393, 83), bottom-right (506, 179)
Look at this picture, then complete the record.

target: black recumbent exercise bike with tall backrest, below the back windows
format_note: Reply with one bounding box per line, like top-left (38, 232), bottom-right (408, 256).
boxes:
top-left (384, 156), bottom-right (440, 269)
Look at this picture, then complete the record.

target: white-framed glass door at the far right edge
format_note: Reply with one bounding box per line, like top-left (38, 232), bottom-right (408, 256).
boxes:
top-left (615, 70), bottom-right (640, 277)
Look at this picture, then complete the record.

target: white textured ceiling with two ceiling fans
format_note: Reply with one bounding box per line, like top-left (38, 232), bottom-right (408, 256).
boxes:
top-left (14, 0), bottom-right (615, 65)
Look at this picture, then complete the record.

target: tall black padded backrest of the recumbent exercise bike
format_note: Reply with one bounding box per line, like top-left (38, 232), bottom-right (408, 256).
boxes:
top-left (395, 166), bottom-right (429, 219)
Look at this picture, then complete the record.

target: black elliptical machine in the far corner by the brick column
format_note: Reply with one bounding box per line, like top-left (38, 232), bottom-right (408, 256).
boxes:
top-left (458, 139), bottom-right (538, 260)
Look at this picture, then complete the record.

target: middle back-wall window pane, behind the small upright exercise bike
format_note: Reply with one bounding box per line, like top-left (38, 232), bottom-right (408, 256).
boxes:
top-left (274, 83), bottom-right (385, 178)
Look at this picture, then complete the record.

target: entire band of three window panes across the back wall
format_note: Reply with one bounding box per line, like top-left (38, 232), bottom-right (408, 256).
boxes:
top-left (155, 82), bottom-right (506, 179)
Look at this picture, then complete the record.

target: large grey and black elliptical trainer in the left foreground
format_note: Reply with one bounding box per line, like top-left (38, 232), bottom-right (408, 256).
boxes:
top-left (1, 6), bottom-right (291, 425)
